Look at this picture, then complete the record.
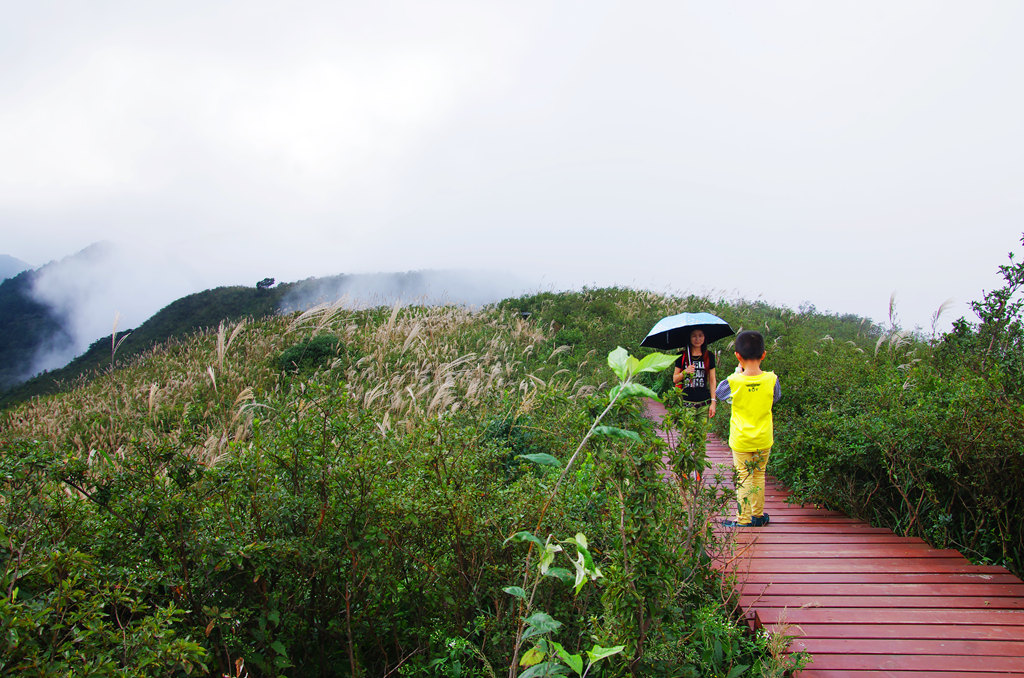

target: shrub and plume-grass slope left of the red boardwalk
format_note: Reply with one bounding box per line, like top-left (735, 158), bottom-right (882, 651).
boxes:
top-left (0, 297), bottom-right (790, 676)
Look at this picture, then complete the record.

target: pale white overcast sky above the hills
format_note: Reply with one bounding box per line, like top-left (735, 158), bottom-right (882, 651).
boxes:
top-left (0, 0), bottom-right (1024, 340)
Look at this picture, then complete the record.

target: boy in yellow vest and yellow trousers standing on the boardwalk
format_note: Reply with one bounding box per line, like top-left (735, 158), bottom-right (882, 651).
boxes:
top-left (715, 331), bottom-right (782, 527)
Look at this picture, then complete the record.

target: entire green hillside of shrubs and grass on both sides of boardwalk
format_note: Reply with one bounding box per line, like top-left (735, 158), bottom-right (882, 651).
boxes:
top-left (0, 235), bottom-right (1024, 678)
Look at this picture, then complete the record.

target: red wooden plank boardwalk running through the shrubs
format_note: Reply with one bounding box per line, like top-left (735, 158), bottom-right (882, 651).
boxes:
top-left (647, 400), bottom-right (1024, 678)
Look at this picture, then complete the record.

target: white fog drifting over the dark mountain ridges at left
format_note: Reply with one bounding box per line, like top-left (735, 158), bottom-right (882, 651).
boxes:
top-left (6, 243), bottom-right (528, 387)
